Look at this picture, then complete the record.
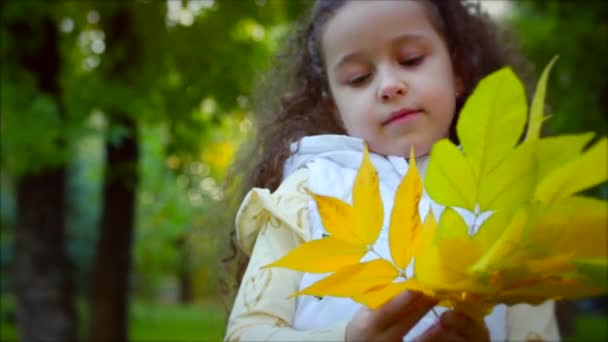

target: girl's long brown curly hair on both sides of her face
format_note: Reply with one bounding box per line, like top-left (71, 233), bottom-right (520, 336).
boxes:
top-left (224, 0), bottom-right (527, 310)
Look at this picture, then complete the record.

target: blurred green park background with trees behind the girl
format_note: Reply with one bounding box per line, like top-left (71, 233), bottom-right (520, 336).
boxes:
top-left (0, 0), bottom-right (608, 341)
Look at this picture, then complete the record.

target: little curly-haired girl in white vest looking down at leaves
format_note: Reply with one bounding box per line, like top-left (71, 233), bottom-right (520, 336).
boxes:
top-left (226, 0), bottom-right (559, 341)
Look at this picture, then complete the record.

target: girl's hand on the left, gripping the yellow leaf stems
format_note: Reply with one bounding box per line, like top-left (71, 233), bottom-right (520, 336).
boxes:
top-left (346, 291), bottom-right (437, 342)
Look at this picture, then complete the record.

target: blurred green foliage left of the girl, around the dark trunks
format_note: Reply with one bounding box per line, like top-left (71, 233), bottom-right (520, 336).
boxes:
top-left (0, 0), bottom-right (308, 304)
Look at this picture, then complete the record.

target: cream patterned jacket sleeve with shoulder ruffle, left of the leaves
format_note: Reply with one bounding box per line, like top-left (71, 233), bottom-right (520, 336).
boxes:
top-left (225, 169), bottom-right (347, 341)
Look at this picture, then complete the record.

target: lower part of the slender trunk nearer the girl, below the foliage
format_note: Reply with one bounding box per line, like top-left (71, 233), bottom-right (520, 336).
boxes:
top-left (89, 116), bottom-right (139, 342)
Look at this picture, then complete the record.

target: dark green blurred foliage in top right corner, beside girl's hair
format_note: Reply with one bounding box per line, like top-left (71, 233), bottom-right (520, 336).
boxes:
top-left (510, 1), bottom-right (608, 136)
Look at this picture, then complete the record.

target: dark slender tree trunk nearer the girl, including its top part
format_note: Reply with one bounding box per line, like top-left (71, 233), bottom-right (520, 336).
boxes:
top-left (89, 3), bottom-right (139, 342)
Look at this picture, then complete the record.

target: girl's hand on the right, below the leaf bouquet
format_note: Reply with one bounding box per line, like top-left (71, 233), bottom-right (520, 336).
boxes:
top-left (417, 310), bottom-right (490, 342)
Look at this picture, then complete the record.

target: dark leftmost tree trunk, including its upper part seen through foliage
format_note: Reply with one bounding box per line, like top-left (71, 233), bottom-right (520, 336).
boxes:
top-left (10, 14), bottom-right (77, 341)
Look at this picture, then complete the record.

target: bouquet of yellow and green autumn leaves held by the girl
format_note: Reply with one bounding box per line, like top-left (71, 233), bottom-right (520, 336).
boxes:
top-left (268, 59), bottom-right (608, 317)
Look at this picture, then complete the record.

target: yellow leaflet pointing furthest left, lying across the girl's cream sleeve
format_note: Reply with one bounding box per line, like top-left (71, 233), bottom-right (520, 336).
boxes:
top-left (265, 237), bottom-right (367, 273)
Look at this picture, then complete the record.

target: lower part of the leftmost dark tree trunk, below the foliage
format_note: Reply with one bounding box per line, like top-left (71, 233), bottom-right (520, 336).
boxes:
top-left (15, 168), bottom-right (76, 341)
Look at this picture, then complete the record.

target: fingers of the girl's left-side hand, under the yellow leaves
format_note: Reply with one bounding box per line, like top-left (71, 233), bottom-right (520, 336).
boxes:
top-left (373, 291), bottom-right (437, 336)
